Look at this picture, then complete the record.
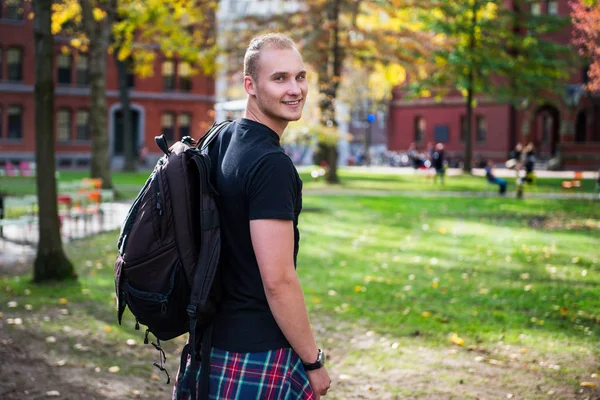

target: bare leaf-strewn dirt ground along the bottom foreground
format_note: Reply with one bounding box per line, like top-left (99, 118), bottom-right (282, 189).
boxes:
top-left (0, 319), bottom-right (600, 400)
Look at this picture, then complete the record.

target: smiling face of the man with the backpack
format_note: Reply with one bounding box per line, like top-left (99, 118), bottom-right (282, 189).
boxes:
top-left (249, 48), bottom-right (308, 128)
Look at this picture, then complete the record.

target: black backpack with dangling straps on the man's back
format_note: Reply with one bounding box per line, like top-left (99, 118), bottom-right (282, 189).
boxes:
top-left (115, 121), bottom-right (229, 394)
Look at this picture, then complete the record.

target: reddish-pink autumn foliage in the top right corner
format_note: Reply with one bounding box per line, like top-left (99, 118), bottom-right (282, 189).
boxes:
top-left (569, 0), bottom-right (600, 92)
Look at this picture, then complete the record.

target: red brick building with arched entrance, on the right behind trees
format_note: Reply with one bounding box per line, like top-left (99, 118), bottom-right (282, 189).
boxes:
top-left (388, 0), bottom-right (600, 169)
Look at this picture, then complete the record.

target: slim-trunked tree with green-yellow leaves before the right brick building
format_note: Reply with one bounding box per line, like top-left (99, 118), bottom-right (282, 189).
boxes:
top-left (411, 0), bottom-right (571, 173)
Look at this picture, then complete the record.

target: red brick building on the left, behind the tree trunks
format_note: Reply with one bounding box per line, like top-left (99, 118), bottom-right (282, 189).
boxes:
top-left (0, 0), bottom-right (215, 167)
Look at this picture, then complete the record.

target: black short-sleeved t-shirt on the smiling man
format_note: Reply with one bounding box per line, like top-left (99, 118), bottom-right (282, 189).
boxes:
top-left (210, 118), bottom-right (302, 353)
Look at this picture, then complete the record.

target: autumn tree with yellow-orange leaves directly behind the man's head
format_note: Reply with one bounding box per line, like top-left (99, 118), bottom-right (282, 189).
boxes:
top-left (227, 0), bottom-right (428, 183)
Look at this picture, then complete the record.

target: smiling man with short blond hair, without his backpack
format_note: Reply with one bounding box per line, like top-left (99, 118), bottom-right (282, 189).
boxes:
top-left (174, 34), bottom-right (331, 400)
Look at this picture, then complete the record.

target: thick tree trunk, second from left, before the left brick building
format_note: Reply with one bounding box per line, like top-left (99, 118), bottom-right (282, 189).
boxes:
top-left (80, 0), bottom-right (116, 189)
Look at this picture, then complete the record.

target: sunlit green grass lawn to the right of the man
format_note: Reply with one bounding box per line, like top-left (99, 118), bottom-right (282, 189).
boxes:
top-left (299, 196), bottom-right (600, 346)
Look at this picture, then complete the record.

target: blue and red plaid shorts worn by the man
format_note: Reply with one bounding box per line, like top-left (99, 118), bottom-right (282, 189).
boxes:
top-left (173, 348), bottom-right (315, 400)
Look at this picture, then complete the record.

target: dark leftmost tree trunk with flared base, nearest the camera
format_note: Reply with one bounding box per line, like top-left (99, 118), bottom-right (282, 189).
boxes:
top-left (33, 0), bottom-right (75, 282)
